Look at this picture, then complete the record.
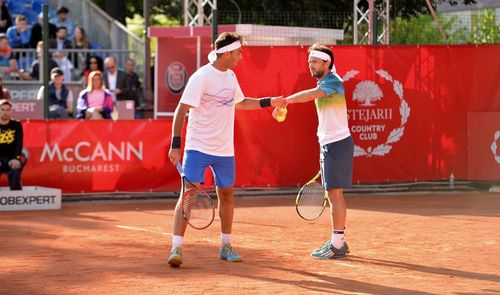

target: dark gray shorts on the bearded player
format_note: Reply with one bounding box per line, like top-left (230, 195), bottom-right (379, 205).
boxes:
top-left (319, 136), bottom-right (354, 189)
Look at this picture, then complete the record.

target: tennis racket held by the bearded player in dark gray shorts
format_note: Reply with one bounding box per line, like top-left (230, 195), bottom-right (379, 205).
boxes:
top-left (295, 171), bottom-right (328, 220)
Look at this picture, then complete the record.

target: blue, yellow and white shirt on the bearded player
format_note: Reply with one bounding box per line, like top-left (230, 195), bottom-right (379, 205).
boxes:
top-left (314, 72), bottom-right (351, 145)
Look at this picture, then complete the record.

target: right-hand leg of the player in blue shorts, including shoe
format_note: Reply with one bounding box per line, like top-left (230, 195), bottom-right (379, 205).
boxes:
top-left (212, 157), bottom-right (241, 262)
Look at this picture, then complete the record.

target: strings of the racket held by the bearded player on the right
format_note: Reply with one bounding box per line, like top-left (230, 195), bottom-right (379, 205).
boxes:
top-left (297, 182), bottom-right (325, 219)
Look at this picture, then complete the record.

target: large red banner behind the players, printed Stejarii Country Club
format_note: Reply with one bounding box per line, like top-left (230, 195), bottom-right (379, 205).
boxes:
top-left (235, 45), bottom-right (500, 185)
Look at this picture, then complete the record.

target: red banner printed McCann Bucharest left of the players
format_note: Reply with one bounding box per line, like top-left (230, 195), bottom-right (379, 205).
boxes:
top-left (10, 120), bottom-right (179, 193)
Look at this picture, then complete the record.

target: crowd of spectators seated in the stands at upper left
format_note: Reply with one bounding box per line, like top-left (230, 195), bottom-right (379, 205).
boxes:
top-left (0, 0), bottom-right (142, 119)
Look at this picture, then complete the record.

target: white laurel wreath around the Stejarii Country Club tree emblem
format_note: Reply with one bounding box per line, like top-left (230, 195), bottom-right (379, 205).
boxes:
top-left (343, 70), bottom-right (410, 157)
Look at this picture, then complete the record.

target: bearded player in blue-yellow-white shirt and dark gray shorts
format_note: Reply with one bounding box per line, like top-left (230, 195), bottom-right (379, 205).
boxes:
top-left (273, 44), bottom-right (354, 259)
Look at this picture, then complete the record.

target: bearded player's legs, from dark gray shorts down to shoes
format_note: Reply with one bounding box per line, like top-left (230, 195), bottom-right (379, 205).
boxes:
top-left (311, 137), bottom-right (354, 259)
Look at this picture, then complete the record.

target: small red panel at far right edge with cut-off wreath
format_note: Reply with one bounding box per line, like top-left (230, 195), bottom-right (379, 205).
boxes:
top-left (467, 112), bottom-right (500, 180)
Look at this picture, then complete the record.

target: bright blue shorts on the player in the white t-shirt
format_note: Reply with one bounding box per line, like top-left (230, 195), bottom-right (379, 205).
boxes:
top-left (182, 150), bottom-right (235, 188)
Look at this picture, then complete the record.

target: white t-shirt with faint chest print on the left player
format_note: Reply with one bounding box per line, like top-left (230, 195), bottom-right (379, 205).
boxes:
top-left (180, 64), bottom-right (245, 156)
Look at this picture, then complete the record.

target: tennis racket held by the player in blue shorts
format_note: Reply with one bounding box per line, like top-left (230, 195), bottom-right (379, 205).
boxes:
top-left (176, 162), bottom-right (215, 229)
